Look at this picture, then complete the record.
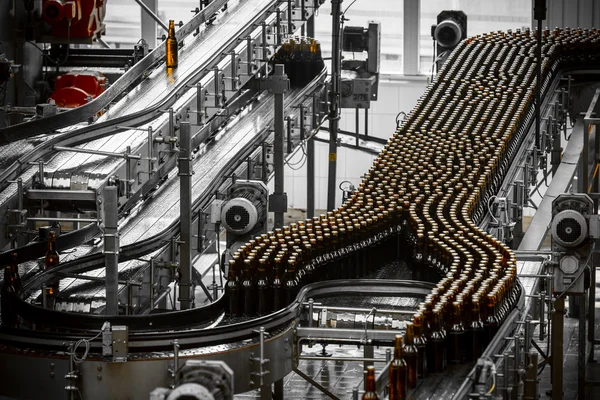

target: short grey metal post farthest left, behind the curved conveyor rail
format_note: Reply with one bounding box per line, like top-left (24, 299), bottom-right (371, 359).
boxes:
top-left (103, 186), bottom-right (119, 315)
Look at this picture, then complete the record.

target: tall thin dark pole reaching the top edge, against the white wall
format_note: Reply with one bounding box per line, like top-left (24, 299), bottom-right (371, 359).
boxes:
top-left (327, 0), bottom-right (343, 211)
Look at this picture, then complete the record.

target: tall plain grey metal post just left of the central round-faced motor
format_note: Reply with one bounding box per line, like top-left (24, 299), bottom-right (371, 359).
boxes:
top-left (179, 122), bottom-right (193, 310)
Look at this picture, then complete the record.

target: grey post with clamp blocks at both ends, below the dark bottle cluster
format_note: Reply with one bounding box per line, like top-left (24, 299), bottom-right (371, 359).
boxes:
top-left (269, 64), bottom-right (290, 228)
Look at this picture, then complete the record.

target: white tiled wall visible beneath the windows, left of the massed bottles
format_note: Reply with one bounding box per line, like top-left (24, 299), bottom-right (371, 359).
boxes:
top-left (285, 76), bottom-right (426, 209)
